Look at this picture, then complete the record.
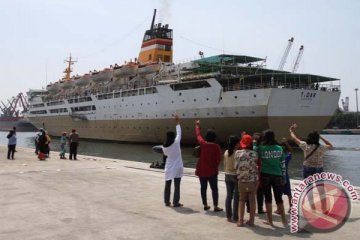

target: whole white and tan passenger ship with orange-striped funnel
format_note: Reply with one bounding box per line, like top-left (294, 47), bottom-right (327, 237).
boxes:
top-left (27, 9), bottom-right (340, 143)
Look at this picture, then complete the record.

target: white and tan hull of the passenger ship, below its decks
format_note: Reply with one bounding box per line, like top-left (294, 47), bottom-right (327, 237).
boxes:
top-left (29, 81), bottom-right (340, 144)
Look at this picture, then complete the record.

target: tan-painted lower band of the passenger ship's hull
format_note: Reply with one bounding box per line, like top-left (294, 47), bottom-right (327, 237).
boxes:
top-left (26, 116), bottom-right (330, 144)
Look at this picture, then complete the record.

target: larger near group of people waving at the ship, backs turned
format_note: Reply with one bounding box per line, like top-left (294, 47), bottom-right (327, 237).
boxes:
top-left (162, 116), bottom-right (332, 227)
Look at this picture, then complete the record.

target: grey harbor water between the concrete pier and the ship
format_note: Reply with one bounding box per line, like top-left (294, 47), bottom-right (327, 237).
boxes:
top-left (0, 132), bottom-right (360, 186)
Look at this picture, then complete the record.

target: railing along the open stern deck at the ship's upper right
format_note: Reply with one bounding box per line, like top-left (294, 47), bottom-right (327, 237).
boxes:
top-left (223, 82), bottom-right (340, 92)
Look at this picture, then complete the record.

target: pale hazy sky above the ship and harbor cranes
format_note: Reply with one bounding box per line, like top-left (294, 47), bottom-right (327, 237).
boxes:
top-left (0, 0), bottom-right (360, 111)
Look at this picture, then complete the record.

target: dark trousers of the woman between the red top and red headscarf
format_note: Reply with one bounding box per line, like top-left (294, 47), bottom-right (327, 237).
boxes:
top-left (225, 174), bottom-right (239, 221)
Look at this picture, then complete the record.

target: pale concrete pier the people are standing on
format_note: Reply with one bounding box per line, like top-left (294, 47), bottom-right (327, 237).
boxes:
top-left (0, 146), bottom-right (360, 240)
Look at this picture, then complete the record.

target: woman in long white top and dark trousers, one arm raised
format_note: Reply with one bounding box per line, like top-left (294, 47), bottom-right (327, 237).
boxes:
top-left (163, 115), bottom-right (184, 207)
